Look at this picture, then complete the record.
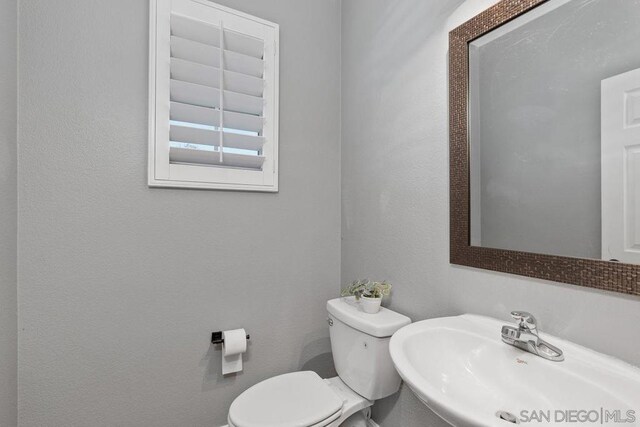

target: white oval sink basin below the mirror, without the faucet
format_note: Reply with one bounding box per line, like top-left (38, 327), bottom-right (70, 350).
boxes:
top-left (389, 314), bottom-right (640, 427)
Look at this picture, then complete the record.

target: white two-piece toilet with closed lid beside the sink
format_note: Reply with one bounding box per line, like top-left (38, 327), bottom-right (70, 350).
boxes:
top-left (228, 297), bottom-right (411, 427)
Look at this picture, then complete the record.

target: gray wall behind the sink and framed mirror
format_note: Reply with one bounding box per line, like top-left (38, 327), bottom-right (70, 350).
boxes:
top-left (342, 0), bottom-right (640, 427)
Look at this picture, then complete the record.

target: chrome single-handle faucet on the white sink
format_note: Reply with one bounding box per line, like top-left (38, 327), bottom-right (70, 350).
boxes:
top-left (502, 311), bottom-right (564, 362)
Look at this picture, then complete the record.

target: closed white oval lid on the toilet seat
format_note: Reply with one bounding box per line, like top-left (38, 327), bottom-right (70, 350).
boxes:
top-left (229, 371), bottom-right (343, 427)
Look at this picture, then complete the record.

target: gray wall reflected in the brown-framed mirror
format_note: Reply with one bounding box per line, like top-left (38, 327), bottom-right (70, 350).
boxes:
top-left (470, 0), bottom-right (640, 259)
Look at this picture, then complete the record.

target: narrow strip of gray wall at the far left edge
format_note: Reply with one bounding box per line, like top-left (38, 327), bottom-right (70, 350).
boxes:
top-left (0, 0), bottom-right (18, 427)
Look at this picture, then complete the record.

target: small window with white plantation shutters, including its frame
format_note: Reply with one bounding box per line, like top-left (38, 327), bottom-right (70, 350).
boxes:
top-left (149, 0), bottom-right (279, 192)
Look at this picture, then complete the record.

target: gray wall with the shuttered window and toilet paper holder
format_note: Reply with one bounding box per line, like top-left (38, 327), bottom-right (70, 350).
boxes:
top-left (18, 0), bottom-right (340, 427)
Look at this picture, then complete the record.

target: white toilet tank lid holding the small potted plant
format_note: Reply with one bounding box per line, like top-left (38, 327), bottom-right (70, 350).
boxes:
top-left (327, 297), bottom-right (411, 338)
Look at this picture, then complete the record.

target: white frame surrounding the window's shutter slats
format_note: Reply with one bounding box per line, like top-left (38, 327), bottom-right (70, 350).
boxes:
top-left (148, 0), bottom-right (280, 192)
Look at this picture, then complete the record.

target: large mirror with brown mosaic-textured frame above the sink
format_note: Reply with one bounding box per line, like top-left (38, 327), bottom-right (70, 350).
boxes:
top-left (449, 0), bottom-right (640, 294)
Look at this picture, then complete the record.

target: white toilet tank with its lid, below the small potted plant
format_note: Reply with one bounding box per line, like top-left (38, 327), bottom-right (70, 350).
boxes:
top-left (327, 297), bottom-right (411, 400)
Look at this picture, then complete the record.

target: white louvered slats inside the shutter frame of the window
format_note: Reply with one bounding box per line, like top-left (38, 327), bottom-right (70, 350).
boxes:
top-left (169, 14), bottom-right (265, 170)
